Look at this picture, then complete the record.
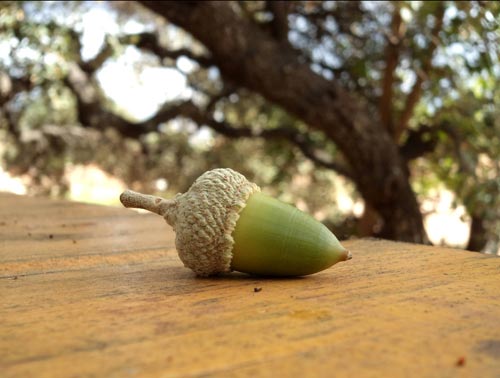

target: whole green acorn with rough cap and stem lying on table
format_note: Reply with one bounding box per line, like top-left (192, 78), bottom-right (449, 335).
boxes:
top-left (120, 168), bottom-right (351, 276)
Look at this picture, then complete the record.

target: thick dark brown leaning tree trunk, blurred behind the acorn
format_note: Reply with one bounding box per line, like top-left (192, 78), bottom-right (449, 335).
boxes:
top-left (142, 1), bottom-right (428, 243)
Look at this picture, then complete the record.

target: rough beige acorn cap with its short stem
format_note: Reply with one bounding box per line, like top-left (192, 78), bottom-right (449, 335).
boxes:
top-left (120, 168), bottom-right (260, 276)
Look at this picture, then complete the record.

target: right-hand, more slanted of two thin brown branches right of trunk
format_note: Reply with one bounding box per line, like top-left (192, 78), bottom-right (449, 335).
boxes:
top-left (394, 3), bottom-right (444, 141)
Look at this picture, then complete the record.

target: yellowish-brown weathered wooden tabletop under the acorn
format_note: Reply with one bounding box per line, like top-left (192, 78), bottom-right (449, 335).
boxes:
top-left (0, 194), bottom-right (500, 377)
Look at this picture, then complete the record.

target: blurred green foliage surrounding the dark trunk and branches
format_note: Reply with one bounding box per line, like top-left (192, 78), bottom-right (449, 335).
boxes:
top-left (0, 1), bottom-right (500, 251)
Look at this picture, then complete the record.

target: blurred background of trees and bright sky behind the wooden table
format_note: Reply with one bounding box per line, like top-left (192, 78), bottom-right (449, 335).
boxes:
top-left (0, 1), bottom-right (500, 253)
